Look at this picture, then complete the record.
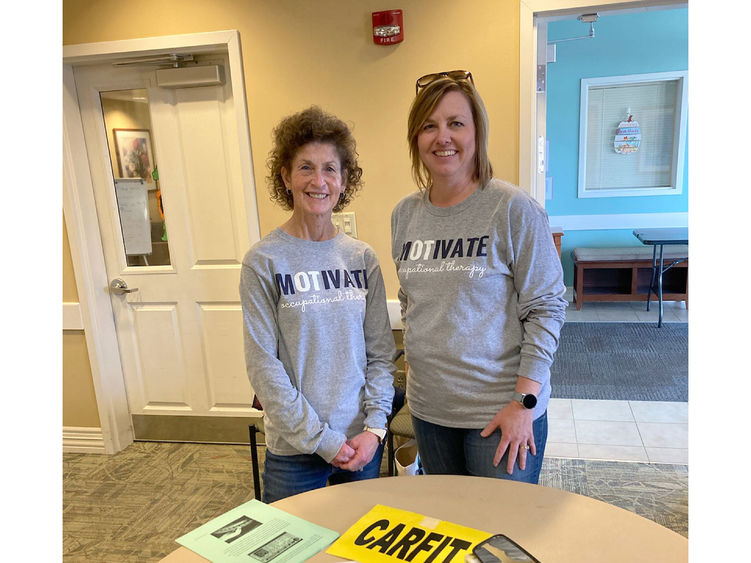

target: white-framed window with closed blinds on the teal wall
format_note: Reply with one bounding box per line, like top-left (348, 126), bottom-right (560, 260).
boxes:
top-left (579, 71), bottom-right (687, 197)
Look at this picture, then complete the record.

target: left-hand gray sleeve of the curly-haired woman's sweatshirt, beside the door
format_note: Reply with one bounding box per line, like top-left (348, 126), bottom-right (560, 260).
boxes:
top-left (240, 263), bottom-right (347, 462)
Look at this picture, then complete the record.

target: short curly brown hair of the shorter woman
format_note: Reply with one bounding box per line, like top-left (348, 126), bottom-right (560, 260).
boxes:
top-left (266, 106), bottom-right (362, 212)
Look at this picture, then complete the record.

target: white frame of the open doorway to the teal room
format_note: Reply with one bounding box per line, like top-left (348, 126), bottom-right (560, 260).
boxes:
top-left (518, 0), bottom-right (687, 206)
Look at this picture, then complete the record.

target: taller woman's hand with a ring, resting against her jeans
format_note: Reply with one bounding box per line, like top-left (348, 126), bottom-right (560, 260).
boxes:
top-left (480, 402), bottom-right (537, 475)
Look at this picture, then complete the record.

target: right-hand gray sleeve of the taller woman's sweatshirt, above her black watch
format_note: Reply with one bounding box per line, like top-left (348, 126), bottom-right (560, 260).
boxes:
top-left (509, 192), bottom-right (568, 383)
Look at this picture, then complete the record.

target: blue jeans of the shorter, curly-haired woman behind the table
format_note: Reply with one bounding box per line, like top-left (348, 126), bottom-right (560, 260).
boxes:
top-left (261, 444), bottom-right (383, 503)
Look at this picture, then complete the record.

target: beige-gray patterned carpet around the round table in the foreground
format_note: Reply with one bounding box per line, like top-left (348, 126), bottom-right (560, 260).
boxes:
top-left (63, 442), bottom-right (688, 563)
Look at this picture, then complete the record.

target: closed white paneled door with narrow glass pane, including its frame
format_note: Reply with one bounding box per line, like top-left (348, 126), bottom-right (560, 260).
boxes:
top-left (64, 32), bottom-right (259, 453)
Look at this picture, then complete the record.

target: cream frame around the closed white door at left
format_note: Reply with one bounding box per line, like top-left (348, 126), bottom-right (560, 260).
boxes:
top-left (62, 30), bottom-right (260, 454)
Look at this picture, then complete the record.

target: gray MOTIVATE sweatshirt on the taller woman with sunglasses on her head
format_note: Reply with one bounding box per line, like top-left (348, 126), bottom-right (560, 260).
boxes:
top-left (391, 179), bottom-right (567, 428)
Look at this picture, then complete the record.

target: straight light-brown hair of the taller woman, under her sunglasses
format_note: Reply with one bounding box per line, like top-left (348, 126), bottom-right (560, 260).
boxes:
top-left (407, 77), bottom-right (493, 190)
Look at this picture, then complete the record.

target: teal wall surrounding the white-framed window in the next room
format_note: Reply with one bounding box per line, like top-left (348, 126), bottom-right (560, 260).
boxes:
top-left (545, 8), bottom-right (689, 285)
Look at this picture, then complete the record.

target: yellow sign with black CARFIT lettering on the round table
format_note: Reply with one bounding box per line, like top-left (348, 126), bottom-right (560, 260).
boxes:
top-left (326, 504), bottom-right (491, 563)
